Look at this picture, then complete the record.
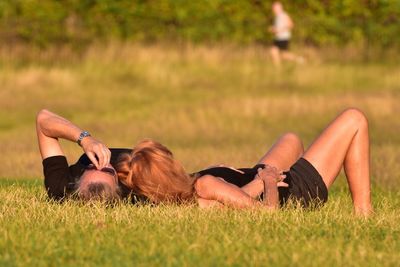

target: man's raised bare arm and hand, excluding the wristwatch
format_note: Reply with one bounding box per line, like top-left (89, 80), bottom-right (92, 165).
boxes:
top-left (36, 109), bottom-right (111, 168)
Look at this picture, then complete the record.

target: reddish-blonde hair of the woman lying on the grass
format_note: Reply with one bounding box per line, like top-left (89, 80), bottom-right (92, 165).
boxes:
top-left (116, 139), bottom-right (195, 203)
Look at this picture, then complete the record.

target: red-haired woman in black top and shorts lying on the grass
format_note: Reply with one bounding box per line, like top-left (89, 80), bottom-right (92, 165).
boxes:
top-left (116, 109), bottom-right (372, 215)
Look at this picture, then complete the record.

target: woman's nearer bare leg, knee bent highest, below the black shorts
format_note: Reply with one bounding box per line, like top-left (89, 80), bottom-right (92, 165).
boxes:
top-left (304, 109), bottom-right (372, 214)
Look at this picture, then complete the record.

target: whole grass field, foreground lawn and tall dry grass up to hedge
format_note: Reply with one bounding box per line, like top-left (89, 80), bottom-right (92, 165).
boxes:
top-left (0, 45), bottom-right (400, 266)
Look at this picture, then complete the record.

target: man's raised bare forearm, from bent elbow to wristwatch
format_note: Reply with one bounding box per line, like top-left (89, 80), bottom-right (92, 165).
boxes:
top-left (37, 110), bottom-right (82, 142)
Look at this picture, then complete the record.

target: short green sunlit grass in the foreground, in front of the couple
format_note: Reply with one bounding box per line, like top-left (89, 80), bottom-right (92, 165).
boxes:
top-left (0, 181), bottom-right (400, 266)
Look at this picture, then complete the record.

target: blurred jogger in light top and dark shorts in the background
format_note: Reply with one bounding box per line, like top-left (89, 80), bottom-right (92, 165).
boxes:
top-left (270, 2), bottom-right (304, 67)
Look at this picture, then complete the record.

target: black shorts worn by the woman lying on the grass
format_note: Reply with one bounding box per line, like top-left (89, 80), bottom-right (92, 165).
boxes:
top-left (279, 158), bottom-right (328, 208)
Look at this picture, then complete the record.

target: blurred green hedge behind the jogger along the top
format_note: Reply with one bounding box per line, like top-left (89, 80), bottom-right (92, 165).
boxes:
top-left (0, 0), bottom-right (400, 47)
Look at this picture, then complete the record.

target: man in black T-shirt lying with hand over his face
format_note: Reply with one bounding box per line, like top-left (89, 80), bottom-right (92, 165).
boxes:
top-left (36, 110), bottom-right (141, 201)
